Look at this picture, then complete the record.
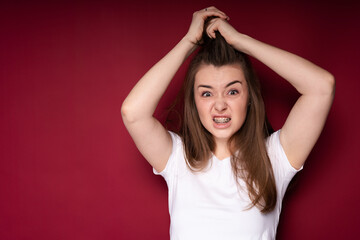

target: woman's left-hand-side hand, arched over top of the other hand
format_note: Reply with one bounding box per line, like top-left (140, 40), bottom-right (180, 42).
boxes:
top-left (185, 7), bottom-right (229, 44)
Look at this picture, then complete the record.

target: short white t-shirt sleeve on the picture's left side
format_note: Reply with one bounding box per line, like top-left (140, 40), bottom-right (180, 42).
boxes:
top-left (153, 131), bottom-right (182, 180)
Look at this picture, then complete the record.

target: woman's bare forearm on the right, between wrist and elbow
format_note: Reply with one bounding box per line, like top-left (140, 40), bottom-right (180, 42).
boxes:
top-left (233, 33), bottom-right (334, 95)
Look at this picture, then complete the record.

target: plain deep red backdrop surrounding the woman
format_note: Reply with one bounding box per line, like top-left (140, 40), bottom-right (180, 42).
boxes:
top-left (0, 0), bottom-right (360, 240)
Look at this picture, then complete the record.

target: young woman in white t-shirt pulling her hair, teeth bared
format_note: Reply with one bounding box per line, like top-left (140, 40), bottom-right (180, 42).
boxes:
top-left (122, 7), bottom-right (335, 240)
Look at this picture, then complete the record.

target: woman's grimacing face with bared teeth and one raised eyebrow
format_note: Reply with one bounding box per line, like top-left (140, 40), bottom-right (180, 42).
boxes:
top-left (194, 64), bottom-right (249, 143)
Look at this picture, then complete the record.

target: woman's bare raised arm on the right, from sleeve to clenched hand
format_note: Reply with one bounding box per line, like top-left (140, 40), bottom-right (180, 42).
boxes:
top-left (207, 19), bottom-right (335, 169)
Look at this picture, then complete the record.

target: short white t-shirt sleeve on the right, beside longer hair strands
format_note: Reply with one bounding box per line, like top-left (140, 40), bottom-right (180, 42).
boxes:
top-left (266, 130), bottom-right (303, 197)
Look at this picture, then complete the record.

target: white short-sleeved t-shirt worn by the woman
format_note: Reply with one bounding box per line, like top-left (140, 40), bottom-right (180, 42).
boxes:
top-left (154, 131), bottom-right (298, 240)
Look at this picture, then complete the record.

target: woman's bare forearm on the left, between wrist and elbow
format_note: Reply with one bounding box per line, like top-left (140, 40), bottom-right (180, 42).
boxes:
top-left (121, 38), bottom-right (195, 122)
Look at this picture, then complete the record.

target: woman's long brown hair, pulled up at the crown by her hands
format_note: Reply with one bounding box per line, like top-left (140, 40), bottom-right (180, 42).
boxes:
top-left (180, 21), bottom-right (277, 213)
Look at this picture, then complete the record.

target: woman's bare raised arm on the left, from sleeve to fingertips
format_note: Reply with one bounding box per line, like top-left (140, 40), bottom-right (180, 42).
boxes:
top-left (121, 7), bottom-right (227, 172)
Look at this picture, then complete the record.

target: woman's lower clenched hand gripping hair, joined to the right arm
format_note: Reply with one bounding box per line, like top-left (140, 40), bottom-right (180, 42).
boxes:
top-left (206, 18), bottom-right (240, 46)
